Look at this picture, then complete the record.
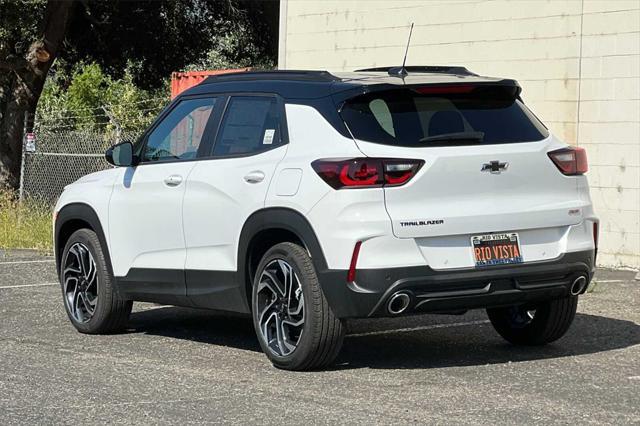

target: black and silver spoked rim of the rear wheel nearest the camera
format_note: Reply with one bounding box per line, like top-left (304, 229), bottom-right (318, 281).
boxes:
top-left (257, 259), bottom-right (304, 356)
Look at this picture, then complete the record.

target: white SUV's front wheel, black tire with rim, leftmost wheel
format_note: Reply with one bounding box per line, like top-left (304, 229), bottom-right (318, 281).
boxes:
top-left (60, 229), bottom-right (133, 334)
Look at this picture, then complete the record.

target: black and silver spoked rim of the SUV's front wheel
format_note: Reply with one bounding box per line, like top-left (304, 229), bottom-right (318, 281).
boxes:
top-left (62, 243), bottom-right (98, 323)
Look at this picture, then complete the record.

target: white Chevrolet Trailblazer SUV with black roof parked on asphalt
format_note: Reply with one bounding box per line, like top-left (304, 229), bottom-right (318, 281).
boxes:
top-left (55, 67), bottom-right (598, 370)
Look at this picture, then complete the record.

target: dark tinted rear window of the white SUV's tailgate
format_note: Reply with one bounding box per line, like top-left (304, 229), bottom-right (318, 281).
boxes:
top-left (340, 86), bottom-right (549, 147)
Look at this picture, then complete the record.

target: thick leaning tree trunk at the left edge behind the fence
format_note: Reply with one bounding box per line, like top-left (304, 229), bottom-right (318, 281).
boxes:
top-left (0, 0), bottom-right (75, 188)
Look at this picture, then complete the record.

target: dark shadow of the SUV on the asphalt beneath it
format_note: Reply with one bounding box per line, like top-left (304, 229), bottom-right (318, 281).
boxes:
top-left (128, 306), bottom-right (640, 370)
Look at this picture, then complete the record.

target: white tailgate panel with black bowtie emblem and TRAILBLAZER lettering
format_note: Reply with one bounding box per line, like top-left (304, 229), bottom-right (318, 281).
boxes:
top-left (358, 138), bottom-right (584, 238)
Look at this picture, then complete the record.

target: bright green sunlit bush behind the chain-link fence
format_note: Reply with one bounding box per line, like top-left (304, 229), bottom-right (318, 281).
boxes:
top-left (37, 63), bottom-right (168, 133)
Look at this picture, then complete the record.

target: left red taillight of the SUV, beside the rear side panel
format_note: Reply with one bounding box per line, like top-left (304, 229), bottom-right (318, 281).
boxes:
top-left (311, 158), bottom-right (424, 189)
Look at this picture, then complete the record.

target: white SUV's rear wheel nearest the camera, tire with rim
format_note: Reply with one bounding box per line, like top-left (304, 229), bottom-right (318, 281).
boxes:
top-left (252, 243), bottom-right (344, 370)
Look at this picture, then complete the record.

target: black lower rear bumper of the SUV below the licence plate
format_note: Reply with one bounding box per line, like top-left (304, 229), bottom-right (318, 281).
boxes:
top-left (318, 250), bottom-right (595, 318)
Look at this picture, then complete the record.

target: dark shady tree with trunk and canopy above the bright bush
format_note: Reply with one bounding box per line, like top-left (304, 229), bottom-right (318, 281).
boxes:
top-left (0, 0), bottom-right (279, 188)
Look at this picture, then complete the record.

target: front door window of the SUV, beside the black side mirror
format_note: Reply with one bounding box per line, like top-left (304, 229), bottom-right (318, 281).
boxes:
top-left (142, 98), bottom-right (216, 162)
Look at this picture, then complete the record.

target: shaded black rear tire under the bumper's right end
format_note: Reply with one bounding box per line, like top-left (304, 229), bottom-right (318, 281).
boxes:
top-left (487, 296), bottom-right (578, 346)
